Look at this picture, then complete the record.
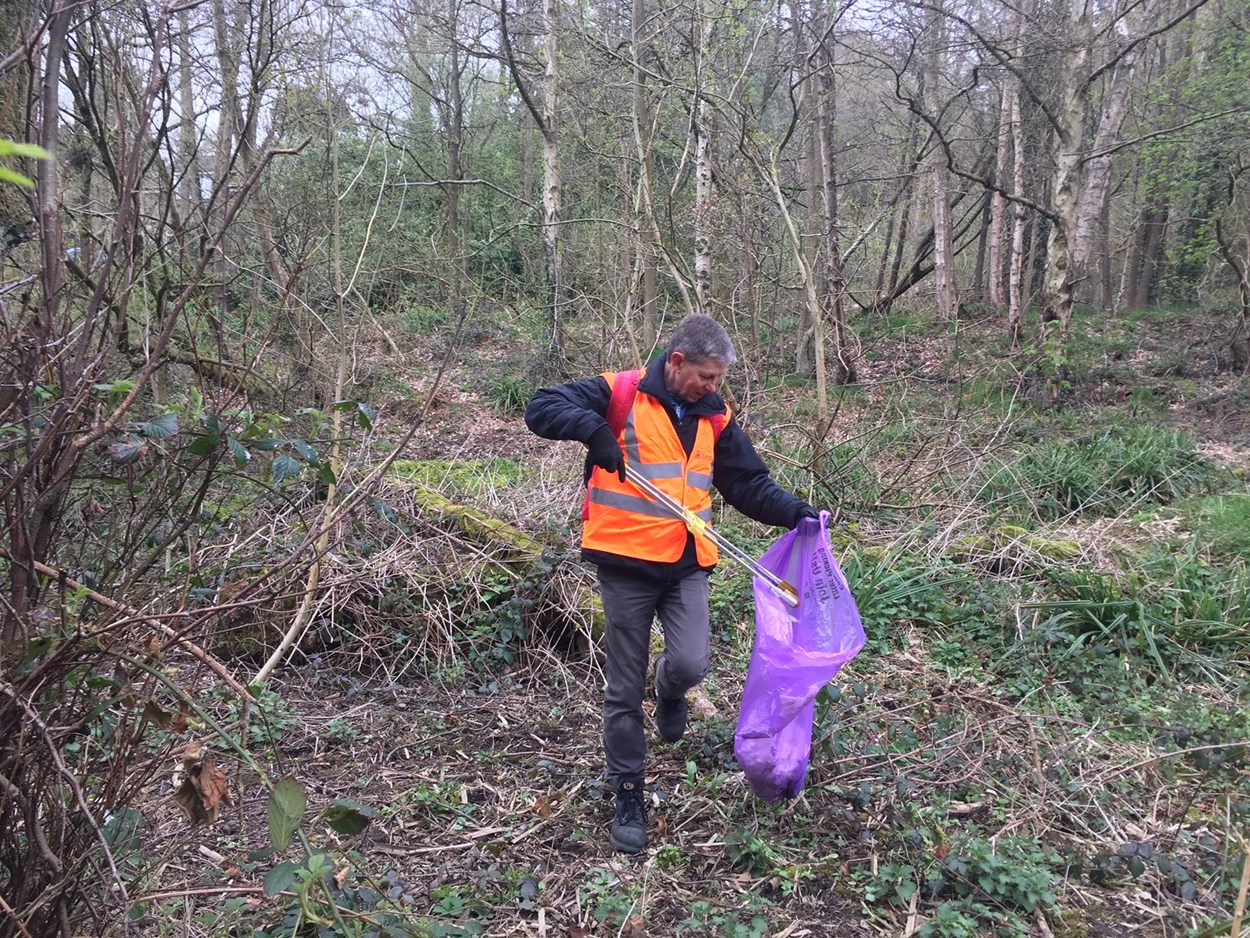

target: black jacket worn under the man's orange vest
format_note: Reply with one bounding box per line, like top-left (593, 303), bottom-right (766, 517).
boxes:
top-left (525, 355), bottom-right (808, 582)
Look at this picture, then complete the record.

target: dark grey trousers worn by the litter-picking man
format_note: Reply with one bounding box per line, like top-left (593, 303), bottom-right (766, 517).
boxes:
top-left (599, 567), bottom-right (709, 785)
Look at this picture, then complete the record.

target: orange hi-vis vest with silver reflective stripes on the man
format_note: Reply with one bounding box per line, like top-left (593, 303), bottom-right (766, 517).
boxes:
top-left (581, 371), bottom-right (729, 567)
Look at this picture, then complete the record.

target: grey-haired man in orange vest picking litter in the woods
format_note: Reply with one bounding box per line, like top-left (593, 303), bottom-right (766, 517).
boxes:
top-left (525, 315), bottom-right (818, 853)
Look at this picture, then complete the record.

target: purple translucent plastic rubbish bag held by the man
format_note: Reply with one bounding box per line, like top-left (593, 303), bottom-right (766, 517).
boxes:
top-left (734, 512), bottom-right (864, 802)
